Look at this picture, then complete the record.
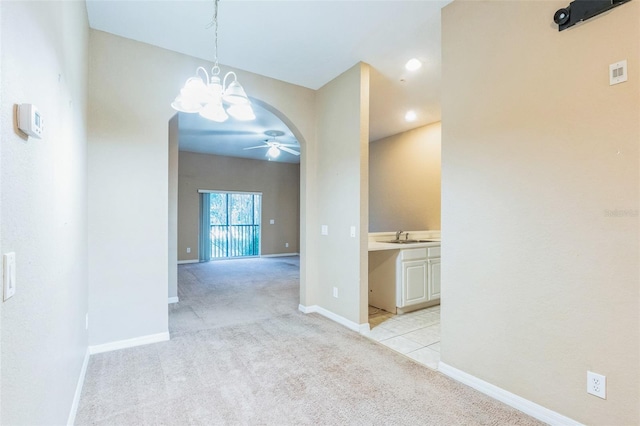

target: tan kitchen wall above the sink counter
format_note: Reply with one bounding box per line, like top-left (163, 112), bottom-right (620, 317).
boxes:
top-left (369, 123), bottom-right (441, 232)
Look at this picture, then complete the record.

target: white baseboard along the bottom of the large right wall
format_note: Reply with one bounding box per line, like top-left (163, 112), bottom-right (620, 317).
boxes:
top-left (438, 361), bottom-right (583, 426)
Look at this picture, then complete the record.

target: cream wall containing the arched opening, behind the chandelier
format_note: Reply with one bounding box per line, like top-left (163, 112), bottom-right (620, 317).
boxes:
top-left (88, 30), bottom-right (315, 345)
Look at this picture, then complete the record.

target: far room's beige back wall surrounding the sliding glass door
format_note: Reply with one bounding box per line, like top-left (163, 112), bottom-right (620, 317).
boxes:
top-left (178, 151), bottom-right (300, 260)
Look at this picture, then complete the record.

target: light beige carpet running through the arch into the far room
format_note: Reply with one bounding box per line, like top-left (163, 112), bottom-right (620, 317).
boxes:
top-left (76, 258), bottom-right (539, 425)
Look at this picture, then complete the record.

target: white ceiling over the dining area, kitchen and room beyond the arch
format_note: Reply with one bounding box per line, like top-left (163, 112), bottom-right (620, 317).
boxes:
top-left (87, 0), bottom-right (450, 162)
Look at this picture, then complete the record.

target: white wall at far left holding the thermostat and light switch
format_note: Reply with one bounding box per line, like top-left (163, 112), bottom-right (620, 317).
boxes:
top-left (0, 1), bottom-right (88, 425)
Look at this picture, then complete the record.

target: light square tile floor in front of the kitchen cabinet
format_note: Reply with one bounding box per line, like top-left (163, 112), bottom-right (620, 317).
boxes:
top-left (366, 305), bottom-right (440, 370)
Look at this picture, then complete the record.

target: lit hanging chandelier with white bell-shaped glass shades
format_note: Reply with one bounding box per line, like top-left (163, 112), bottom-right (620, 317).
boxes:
top-left (171, 0), bottom-right (256, 123)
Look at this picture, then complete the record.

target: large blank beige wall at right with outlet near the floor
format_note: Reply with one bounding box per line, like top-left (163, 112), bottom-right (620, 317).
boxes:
top-left (442, 1), bottom-right (640, 425)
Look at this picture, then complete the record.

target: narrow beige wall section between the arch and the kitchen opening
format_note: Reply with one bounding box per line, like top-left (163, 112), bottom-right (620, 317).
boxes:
top-left (311, 64), bottom-right (369, 324)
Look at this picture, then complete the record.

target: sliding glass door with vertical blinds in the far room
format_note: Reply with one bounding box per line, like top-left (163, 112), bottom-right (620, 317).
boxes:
top-left (199, 190), bottom-right (262, 262)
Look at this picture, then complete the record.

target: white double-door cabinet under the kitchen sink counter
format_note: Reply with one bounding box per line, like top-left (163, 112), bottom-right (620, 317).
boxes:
top-left (396, 247), bottom-right (440, 308)
